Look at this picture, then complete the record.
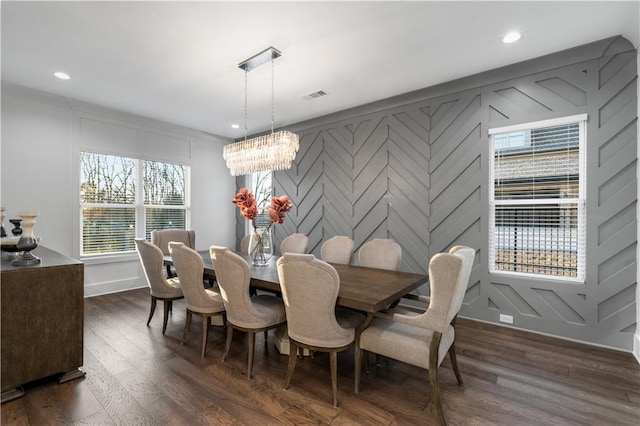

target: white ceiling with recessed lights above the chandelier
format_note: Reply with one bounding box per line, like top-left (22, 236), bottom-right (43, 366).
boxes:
top-left (0, 1), bottom-right (640, 138)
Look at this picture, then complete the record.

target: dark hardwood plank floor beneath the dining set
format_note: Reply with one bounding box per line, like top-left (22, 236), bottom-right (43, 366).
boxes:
top-left (0, 289), bottom-right (640, 426)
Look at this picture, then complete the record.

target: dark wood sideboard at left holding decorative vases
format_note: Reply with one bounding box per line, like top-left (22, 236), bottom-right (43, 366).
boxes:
top-left (0, 247), bottom-right (85, 402)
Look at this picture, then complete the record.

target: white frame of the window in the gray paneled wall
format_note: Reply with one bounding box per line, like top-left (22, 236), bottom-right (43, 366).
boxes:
top-left (487, 114), bottom-right (588, 284)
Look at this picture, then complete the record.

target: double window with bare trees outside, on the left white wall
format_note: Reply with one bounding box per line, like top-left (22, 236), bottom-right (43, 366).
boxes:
top-left (80, 152), bottom-right (190, 256)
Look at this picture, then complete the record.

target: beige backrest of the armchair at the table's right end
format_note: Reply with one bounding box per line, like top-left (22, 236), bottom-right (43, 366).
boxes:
top-left (422, 246), bottom-right (476, 333)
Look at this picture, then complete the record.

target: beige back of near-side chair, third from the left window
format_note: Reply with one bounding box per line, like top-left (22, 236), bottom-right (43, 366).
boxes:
top-left (209, 246), bottom-right (263, 328)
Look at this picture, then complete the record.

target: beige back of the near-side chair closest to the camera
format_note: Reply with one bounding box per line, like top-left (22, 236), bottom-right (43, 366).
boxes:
top-left (278, 253), bottom-right (355, 348)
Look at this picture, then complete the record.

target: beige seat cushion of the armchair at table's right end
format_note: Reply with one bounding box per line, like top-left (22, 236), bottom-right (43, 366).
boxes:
top-left (360, 318), bottom-right (455, 369)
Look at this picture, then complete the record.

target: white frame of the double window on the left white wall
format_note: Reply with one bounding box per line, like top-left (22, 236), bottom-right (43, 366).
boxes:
top-left (77, 153), bottom-right (191, 263)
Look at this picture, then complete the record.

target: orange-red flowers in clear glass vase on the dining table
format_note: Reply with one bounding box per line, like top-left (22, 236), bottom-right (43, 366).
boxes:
top-left (233, 187), bottom-right (293, 265)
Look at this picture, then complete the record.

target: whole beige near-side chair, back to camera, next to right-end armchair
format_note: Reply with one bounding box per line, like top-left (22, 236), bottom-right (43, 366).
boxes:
top-left (278, 253), bottom-right (364, 406)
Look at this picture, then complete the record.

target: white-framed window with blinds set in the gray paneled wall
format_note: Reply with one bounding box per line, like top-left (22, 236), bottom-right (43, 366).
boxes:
top-left (489, 116), bottom-right (586, 281)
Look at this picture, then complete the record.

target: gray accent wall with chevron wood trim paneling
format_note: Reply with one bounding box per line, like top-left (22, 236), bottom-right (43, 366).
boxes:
top-left (237, 37), bottom-right (638, 351)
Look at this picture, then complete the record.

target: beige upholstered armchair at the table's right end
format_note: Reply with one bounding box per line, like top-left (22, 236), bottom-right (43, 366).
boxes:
top-left (355, 246), bottom-right (476, 425)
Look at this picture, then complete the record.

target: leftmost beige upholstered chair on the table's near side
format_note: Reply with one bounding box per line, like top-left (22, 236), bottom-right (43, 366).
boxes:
top-left (135, 238), bottom-right (183, 334)
